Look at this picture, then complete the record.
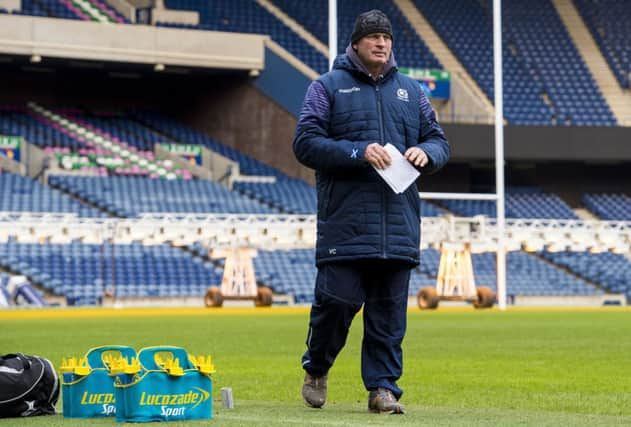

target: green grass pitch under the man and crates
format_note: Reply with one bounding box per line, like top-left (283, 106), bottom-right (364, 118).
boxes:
top-left (0, 308), bottom-right (631, 427)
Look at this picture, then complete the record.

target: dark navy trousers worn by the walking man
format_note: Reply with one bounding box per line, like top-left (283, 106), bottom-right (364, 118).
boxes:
top-left (302, 260), bottom-right (411, 399)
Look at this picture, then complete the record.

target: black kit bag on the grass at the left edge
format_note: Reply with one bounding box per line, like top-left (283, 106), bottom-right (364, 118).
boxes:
top-left (0, 353), bottom-right (59, 418)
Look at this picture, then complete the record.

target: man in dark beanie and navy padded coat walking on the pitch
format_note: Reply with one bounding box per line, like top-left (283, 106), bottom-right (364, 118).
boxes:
top-left (293, 10), bottom-right (450, 414)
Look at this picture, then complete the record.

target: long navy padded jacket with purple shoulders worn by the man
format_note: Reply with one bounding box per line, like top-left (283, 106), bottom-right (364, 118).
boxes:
top-left (293, 47), bottom-right (450, 265)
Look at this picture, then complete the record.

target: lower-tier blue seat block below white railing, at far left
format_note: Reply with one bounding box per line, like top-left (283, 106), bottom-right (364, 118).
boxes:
top-left (0, 240), bottom-right (222, 305)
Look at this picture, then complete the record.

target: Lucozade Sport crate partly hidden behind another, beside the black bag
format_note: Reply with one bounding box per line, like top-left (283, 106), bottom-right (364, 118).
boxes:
top-left (60, 345), bottom-right (136, 418)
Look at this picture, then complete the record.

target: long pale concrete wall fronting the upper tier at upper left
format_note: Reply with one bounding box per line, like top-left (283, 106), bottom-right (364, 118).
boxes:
top-left (0, 15), bottom-right (267, 70)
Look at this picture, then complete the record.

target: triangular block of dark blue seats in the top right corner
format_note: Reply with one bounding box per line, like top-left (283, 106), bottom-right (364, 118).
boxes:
top-left (574, 0), bottom-right (631, 89)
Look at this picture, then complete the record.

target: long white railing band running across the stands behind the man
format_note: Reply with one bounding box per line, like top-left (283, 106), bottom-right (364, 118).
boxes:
top-left (0, 212), bottom-right (631, 253)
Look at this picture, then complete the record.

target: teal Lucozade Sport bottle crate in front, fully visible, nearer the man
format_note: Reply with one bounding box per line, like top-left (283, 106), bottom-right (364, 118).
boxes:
top-left (112, 346), bottom-right (214, 422)
